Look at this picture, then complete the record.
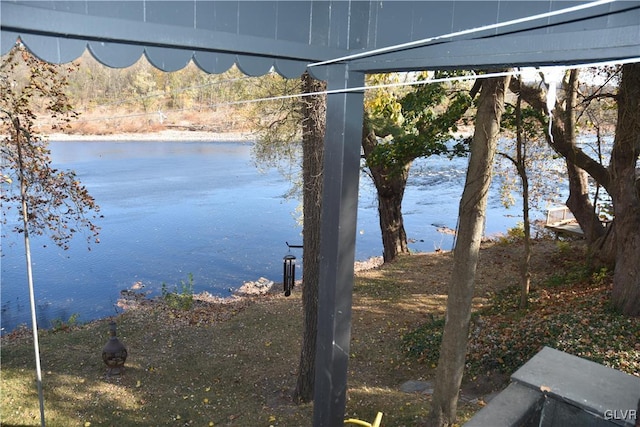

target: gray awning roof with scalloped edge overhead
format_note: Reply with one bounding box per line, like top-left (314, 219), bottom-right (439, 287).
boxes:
top-left (5, 0), bottom-right (640, 78)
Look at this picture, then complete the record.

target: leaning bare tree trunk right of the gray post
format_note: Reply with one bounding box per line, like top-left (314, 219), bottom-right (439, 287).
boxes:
top-left (428, 72), bottom-right (509, 426)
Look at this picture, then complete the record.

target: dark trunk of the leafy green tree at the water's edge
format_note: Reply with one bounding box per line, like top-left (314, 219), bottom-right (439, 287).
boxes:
top-left (362, 121), bottom-right (411, 262)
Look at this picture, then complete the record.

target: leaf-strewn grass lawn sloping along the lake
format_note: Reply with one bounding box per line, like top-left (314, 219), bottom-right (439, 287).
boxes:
top-left (0, 241), bottom-right (640, 427)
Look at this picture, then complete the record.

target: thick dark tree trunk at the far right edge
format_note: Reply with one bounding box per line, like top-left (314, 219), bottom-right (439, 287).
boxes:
top-left (610, 64), bottom-right (640, 316)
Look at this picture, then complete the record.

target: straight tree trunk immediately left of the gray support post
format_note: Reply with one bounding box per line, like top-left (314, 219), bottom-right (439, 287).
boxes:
top-left (293, 73), bottom-right (326, 402)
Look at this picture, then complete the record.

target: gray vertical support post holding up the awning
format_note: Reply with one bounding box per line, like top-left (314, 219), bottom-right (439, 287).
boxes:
top-left (313, 64), bottom-right (364, 427)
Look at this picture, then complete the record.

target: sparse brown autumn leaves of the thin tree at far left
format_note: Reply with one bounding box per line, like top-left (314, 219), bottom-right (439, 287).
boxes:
top-left (0, 46), bottom-right (99, 249)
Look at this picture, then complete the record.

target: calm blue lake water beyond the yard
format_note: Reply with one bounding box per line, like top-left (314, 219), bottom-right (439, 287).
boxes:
top-left (0, 142), bottom-right (520, 332)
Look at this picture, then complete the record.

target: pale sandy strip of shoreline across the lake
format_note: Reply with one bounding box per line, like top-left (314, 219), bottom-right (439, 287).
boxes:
top-left (43, 130), bottom-right (255, 143)
